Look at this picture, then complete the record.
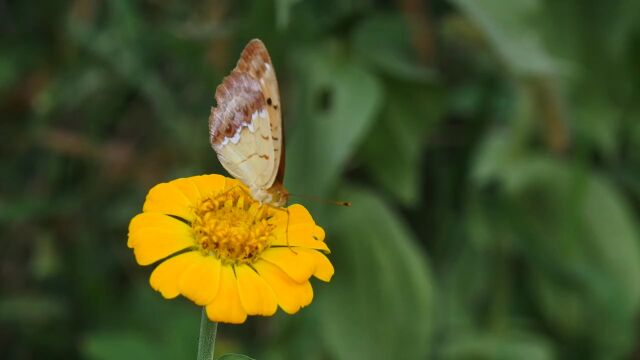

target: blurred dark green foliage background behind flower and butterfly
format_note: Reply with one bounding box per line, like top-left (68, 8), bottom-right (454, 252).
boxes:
top-left (0, 0), bottom-right (640, 360)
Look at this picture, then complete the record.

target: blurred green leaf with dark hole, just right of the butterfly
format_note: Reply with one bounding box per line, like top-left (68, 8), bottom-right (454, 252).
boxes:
top-left (286, 48), bottom-right (382, 195)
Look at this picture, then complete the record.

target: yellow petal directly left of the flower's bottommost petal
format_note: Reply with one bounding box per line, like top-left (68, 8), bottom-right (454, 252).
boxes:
top-left (178, 256), bottom-right (221, 305)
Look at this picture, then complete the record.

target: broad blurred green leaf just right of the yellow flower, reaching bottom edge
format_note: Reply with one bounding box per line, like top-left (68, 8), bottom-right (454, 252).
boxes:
top-left (317, 187), bottom-right (433, 359)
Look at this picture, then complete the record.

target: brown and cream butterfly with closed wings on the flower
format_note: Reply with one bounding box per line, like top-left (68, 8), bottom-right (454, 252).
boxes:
top-left (209, 39), bottom-right (289, 207)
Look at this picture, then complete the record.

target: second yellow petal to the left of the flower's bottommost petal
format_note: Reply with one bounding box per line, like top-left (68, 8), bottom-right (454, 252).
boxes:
top-left (149, 251), bottom-right (202, 299)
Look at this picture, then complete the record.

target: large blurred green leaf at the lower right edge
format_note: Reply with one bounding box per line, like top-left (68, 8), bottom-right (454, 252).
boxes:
top-left (478, 156), bottom-right (640, 355)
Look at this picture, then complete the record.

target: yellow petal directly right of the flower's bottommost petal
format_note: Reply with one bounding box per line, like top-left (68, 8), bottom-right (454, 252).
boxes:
top-left (236, 265), bottom-right (278, 315)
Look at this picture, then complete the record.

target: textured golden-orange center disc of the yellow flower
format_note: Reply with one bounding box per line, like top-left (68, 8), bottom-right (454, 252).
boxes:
top-left (191, 188), bottom-right (275, 264)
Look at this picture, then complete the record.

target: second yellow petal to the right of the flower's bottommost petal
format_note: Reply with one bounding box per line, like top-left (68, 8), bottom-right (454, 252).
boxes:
top-left (253, 261), bottom-right (313, 314)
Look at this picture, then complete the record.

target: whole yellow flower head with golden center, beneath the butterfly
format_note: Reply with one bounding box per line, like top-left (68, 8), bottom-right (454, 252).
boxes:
top-left (127, 175), bottom-right (333, 323)
